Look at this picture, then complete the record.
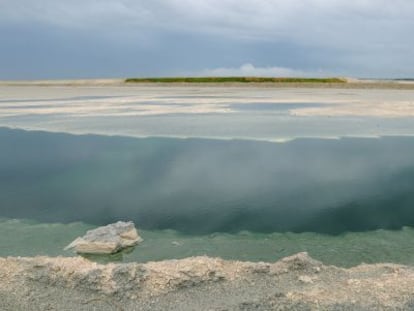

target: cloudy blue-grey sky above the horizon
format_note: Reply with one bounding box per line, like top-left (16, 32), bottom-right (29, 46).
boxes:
top-left (0, 0), bottom-right (414, 80)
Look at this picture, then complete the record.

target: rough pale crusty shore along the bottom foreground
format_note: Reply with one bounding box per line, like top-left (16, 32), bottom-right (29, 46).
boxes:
top-left (0, 253), bottom-right (414, 311)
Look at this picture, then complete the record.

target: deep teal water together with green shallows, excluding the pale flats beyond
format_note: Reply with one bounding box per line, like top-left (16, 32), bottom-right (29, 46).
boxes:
top-left (0, 128), bottom-right (414, 266)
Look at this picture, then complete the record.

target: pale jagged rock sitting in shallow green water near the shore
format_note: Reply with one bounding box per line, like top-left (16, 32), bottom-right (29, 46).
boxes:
top-left (65, 221), bottom-right (142, 254)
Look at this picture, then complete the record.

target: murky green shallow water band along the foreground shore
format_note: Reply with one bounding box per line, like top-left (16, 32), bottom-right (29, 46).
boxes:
top-left (0, 219), bottom-right (414, 267)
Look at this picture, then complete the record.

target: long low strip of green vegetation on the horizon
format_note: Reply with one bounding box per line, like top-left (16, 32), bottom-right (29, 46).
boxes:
top-left (125, 77), bottom-right (346, 83)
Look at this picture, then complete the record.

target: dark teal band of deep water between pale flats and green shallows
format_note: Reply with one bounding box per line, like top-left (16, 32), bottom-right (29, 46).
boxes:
top-left (0, 128), bottom-right (414, 235)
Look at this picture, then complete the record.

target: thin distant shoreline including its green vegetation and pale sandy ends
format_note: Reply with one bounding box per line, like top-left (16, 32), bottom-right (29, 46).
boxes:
top-left (0, 77), bottom-right (414, 90)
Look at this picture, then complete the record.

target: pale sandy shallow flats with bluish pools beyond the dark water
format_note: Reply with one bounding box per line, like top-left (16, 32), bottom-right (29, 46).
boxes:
top-left (0, 86), bottom-right (414, 141)
